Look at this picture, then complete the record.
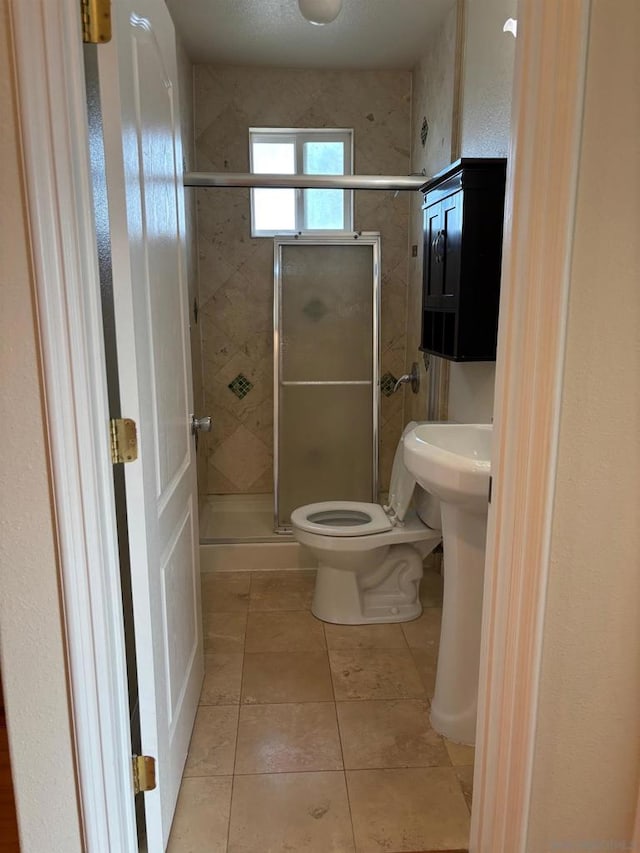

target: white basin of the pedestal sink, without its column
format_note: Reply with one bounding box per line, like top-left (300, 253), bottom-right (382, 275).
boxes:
top-left (404, 423), bottom-right (493, 510)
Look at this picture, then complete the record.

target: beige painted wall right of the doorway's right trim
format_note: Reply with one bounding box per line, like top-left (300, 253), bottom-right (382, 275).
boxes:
top-left (527, 0), bottom-right (640, 853)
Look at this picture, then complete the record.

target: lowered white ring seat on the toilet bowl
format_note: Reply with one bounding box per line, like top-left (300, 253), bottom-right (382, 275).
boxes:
top-left (291, 501), bottom-right (393, 537)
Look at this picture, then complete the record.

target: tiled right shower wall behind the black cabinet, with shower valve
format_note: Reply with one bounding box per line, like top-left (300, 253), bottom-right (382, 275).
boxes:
top-left (405, 6), bottom-right (457, 422)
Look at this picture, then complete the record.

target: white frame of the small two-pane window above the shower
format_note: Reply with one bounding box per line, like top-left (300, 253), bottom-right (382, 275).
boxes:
top-left (249, 127), bottom-right (354, 237)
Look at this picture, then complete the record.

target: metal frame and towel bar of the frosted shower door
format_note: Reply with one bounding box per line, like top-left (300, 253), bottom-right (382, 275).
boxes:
top-left (273, 231), bottom-right (382, 534)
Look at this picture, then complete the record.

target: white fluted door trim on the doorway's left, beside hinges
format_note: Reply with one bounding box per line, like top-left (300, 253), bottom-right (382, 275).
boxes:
top-left (10, 0), bottom-right (138, 853)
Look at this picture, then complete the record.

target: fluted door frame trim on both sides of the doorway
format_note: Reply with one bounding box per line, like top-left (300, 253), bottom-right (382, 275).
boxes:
top-left (10, 0), bottom-right (640, 853)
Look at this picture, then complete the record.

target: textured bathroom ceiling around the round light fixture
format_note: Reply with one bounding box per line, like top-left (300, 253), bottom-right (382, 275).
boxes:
top-left (166, 0), bottom-right (455, 70)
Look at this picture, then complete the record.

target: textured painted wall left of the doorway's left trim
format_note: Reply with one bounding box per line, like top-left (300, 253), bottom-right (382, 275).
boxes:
top-left (0, 0), bottom-right (82, 853)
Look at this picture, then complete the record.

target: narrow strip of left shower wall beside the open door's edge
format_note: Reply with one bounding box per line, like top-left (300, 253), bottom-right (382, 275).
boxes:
top-left (176, 33), bottom-right (208, 496)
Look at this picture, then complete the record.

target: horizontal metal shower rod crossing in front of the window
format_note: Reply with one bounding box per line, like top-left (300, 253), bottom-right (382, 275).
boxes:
top-left (184, 172), bottom-right (428, 190)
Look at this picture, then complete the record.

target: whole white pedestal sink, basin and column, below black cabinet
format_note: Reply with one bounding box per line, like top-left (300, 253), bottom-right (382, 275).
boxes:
top-left (404, 423), bottom-right (492, 744)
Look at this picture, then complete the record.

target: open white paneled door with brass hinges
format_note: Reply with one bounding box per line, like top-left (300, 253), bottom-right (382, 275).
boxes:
top-left (98, 0), bottom-right (203, 853)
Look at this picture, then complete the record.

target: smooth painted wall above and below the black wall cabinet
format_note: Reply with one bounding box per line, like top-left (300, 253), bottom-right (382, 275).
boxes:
top-left (448, 0), bottom-right (518, 423)
